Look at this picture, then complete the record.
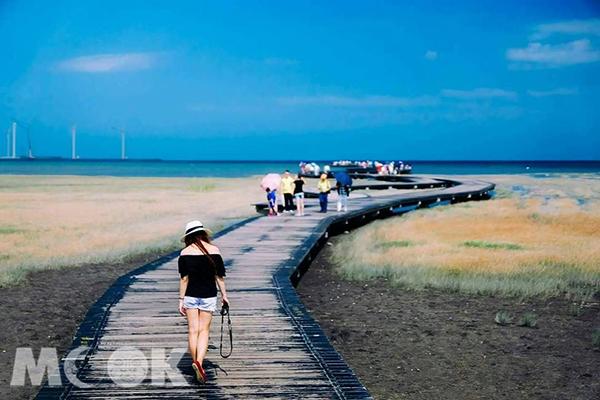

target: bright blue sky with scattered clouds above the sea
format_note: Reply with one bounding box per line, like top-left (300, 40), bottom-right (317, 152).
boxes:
top-left (0, 1), bottom-right (600, 160)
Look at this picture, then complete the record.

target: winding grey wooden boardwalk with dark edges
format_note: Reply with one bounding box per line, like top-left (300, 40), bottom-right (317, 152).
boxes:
top-left (38, 177), bottom-right (494, 399)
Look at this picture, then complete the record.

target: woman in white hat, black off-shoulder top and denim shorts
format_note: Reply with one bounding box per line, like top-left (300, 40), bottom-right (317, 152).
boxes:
top-left (179, 221), bottom-right (229, 383)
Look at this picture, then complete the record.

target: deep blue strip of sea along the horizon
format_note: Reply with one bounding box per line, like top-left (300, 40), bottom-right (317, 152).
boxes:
top-left (0, 158), bottom-right (600, 177)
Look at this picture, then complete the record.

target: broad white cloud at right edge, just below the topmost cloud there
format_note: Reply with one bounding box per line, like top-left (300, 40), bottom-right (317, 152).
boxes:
top-left (506, 39), bottom-right (600, 69)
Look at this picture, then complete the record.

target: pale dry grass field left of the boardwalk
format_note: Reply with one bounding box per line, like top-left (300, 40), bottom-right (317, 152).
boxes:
top-left (0, 175), bottom-right (264, 286)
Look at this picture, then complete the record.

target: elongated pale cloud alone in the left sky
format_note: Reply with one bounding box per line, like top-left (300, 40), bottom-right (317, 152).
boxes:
top-left (58, 53), bottom-right (158, 73)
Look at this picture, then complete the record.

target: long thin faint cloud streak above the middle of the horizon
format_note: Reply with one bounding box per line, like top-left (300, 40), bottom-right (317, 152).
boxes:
top-left (278, 95), bottom-right (439, 108)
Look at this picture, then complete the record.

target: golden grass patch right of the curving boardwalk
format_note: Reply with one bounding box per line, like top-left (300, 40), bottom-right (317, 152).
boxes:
top-left (333, 174), bottom-right (600, 297)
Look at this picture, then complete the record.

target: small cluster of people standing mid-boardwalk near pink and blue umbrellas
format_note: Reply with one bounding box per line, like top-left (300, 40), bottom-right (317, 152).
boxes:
top-left (266, 170), bottom-right (350, 217)
